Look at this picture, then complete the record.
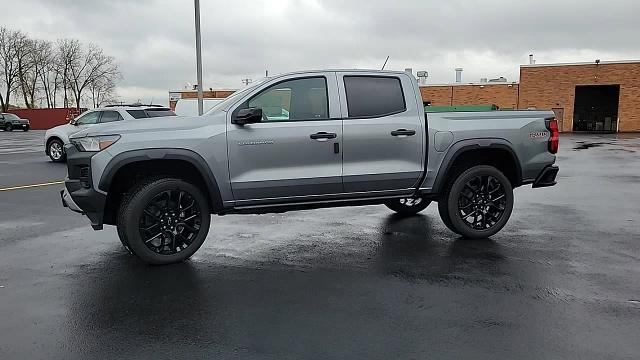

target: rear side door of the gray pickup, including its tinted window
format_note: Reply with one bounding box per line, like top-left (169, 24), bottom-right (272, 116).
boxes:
top-left (338, 72), bottom-right (426, 193)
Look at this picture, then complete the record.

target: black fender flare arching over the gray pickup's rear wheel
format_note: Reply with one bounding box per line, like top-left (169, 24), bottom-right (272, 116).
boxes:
top-left (433, 138), bottom-right (522, 193)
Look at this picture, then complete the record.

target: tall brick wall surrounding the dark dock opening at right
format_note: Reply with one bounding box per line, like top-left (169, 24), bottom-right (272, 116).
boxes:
top-left (519, 63), bottom-right (640, 132)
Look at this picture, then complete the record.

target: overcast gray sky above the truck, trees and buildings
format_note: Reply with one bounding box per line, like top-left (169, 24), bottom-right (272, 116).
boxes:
top-left (0, 0), bottom-right (640, 103)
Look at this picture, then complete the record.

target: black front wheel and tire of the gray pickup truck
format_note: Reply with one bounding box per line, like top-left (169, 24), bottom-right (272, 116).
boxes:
top-left (117, 178), bottom-right (211, 265)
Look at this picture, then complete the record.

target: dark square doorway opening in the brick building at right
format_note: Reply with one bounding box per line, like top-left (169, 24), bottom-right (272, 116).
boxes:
top-left (573, 85), bottom-right (620, 133)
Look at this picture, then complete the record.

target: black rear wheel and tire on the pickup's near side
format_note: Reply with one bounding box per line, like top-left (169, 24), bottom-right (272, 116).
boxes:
top-left (438, 165), bottom-right (513, 239)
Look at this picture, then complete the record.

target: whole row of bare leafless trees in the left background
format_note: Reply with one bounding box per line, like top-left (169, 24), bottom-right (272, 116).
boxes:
top-left (0, 27), bottom-right (122, 111)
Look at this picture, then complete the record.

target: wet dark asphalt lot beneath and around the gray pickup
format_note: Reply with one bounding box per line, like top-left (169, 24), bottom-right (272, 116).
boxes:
top-left (0, 132), bottom-right (640, 359)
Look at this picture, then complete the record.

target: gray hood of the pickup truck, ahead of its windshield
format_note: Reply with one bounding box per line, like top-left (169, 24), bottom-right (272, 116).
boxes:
top-left (71, 111), bottom-right (226, 138)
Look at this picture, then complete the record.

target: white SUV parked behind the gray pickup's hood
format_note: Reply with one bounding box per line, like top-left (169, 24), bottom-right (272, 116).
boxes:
top-left (44, 104), bottom-right (176, 162)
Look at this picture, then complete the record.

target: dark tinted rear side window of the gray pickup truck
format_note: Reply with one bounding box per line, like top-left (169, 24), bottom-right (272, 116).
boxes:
top-left (344, 76), bottom-right (406, 118)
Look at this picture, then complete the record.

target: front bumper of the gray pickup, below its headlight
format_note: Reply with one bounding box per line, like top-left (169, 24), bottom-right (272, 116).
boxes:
top-left (60, 145), bottom-right (107, 230)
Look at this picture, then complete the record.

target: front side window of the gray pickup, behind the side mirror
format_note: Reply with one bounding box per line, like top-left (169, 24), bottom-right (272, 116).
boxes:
top-left (248, 77), bottom-right (329, 122)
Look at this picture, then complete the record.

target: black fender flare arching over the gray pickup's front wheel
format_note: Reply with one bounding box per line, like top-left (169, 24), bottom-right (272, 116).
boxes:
top-left (98, 148), bottom-right (223, 210)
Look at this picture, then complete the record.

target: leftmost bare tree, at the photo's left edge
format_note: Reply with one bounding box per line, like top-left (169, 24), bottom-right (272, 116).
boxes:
top-left (0, 27), bottom-right (19, 111)
